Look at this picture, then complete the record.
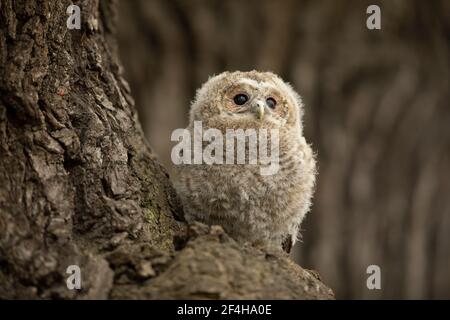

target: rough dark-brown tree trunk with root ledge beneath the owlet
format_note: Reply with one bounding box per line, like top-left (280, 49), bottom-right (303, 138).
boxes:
top-left (0, 0), bottom-right (333, 299)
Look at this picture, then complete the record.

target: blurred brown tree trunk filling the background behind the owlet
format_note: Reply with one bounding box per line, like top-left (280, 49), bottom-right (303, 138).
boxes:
top-left (119, 0), bottom-right (450, 298)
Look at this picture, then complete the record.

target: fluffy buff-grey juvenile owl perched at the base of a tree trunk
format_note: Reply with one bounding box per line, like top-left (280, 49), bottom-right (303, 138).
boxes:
top-left (175, 71), bottom-right (316, 251)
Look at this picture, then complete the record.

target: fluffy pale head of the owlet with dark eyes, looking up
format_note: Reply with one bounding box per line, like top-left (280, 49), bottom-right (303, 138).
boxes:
top-left (190, 71), bottom-right (303, 131)
